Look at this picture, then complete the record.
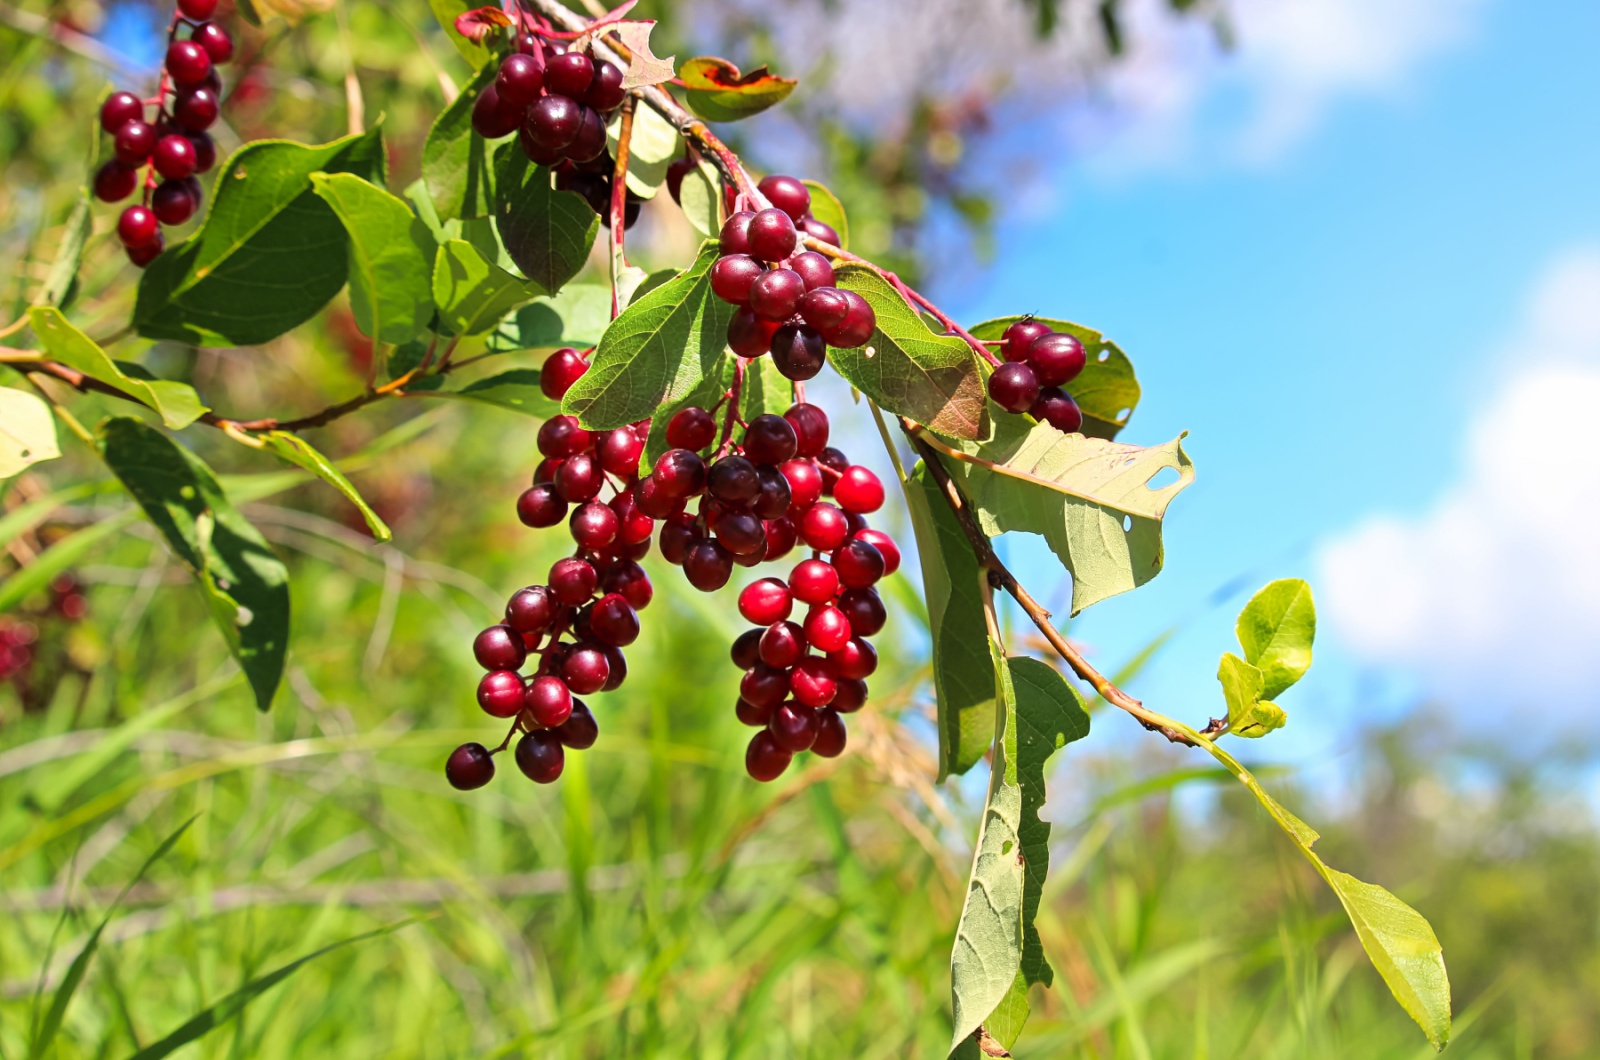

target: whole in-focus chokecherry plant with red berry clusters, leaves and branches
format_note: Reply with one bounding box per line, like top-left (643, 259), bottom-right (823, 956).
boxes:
top-left (0, 0), bottom-right (1450, 1055)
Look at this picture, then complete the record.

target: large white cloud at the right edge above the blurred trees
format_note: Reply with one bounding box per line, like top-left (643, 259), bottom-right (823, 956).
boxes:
top-left (1318, 250), bottom-right (1600, 717)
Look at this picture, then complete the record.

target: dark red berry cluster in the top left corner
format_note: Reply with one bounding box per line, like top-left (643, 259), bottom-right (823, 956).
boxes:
top-left (94, 0), bottom-right (234, 269)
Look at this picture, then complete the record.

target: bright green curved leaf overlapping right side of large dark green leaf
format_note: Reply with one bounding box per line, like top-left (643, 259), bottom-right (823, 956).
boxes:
top-left (310, 173), bottom-right (435, 346)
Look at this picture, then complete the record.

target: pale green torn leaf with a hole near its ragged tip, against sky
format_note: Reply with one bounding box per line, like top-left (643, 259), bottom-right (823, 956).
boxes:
top-left (946, 413), bottom-right (1194, 615)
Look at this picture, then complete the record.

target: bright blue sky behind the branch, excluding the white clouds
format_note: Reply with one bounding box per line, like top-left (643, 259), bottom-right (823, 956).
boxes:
top-left (939, 0), bottom-right (1600, 757)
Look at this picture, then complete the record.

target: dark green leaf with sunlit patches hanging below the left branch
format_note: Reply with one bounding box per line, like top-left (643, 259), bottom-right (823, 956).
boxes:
top-left (99, 416), bottom-right (290, 711)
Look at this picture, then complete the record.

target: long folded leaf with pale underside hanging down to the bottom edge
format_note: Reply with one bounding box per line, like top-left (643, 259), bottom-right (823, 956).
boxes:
top-left (950, 639), bottom-right (1090, 1052)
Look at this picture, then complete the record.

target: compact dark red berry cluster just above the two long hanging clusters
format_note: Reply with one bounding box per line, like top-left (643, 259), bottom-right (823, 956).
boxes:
top-left (710, 175), bottom-right (877, 381)
